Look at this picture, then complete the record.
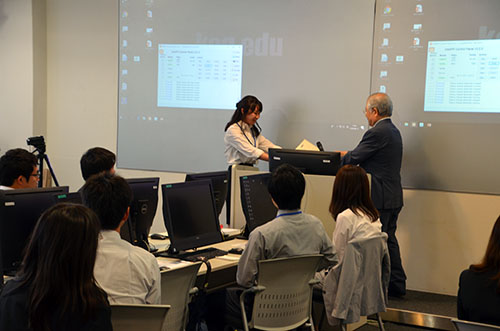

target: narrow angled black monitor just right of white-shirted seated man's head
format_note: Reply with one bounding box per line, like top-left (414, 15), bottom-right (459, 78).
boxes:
top-left (124, 177), bottom-right (160, 251)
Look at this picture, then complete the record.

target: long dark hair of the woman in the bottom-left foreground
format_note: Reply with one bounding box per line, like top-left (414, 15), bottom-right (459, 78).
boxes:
top-left (17, 203), bottom-right (108, 331)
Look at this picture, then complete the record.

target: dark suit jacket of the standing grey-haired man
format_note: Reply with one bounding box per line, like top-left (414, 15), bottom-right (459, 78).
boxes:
top-left (342, 118), bottom-right (403, 209)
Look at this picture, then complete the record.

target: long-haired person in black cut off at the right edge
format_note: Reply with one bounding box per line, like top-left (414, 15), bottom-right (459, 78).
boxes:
top-left (457, 216), bottom-right (500, 326)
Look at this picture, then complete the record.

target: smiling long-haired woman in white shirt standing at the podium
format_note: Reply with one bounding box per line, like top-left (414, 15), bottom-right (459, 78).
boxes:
top-left (224, 95), bottom-right (279, 165)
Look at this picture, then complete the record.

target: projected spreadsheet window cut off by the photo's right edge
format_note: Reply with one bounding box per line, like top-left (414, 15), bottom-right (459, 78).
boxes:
top-left (424, 39), bottom-right (500, 113)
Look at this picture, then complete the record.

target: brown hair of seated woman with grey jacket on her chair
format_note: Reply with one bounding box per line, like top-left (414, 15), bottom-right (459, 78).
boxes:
top-left (330, 165), bottom-right (379, 222)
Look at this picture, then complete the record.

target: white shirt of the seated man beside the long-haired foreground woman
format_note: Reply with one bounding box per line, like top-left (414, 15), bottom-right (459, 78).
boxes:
top-left (94, 230), bottom-right (161, 304)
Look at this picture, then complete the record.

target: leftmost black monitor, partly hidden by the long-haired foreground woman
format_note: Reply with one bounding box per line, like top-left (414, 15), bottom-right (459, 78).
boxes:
top-left (0, 186), bottom-right (68, 275)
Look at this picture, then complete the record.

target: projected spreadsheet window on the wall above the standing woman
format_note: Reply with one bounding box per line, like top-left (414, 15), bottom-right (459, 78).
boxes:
top-left (157, 44), bottom-right (243, 109)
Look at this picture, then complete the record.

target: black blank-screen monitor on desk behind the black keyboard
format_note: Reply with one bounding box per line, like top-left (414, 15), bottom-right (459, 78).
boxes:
top-left (161, 180), bottom-right (222, 253)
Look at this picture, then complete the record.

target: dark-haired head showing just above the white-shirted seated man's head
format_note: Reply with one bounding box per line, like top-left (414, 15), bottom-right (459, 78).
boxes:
top-left (80, 147), bottom-right (116, 180)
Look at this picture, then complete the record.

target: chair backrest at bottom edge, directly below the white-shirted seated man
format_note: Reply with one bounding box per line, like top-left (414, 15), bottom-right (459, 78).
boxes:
top-left (111, 304), bottom-right (170, 331)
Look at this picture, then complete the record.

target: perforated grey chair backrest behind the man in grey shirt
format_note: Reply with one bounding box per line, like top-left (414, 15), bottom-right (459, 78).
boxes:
top-left (250, 254), bottom-right (322, 330)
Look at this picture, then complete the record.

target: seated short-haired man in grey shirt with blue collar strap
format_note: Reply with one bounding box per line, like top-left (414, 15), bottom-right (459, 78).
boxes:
top-left (222, 164), bottom-right (337, 328)
